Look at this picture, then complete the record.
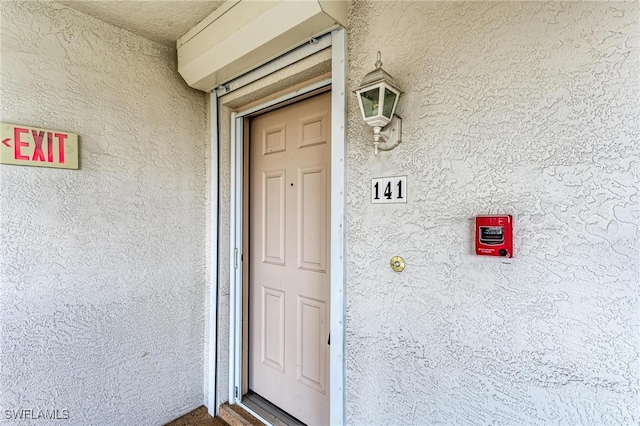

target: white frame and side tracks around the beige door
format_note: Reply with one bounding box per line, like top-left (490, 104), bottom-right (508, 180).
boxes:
top-left (208, 29), bottom-right (347, 425)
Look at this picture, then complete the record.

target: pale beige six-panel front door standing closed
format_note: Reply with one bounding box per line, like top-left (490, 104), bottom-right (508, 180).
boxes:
top-left (248, 92), bottom-right (331, 425)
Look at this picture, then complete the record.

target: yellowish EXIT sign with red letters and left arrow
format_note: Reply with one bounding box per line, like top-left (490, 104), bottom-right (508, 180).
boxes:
top-left (0, 123), bottom-right (78, 169)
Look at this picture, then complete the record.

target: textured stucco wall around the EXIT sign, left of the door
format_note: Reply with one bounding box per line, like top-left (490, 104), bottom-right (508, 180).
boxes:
top-left (0, 1), bottom-right (208, 425)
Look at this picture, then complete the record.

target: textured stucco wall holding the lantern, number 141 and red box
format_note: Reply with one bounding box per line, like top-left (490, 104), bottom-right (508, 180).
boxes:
top-left (347, 1), bottom-right (640, 425)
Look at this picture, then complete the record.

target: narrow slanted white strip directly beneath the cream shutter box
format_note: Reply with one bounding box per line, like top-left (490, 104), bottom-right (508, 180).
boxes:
top-left (213, 33), bottom-right (331, 97)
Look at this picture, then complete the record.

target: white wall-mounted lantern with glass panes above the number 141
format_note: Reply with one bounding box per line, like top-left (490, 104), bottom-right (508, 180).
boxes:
top-left (354, 52), bottom-right (402, 155)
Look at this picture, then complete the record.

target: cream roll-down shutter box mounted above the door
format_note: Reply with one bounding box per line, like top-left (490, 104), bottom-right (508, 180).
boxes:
top-left (177, 0), bottom-right (347, 91)
